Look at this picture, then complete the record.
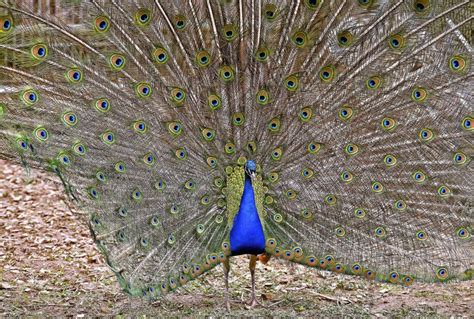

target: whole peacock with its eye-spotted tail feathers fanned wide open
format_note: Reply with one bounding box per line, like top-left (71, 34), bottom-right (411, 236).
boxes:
top-left (0, 0), bottom-right (474, 307)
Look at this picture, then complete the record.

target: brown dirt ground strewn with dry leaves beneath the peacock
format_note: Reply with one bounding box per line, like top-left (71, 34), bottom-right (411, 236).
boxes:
top-left (0, 160), bottom-right (474, 318)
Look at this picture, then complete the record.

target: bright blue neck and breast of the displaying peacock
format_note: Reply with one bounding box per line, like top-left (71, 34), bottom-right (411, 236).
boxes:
top-left (230, 175), bottom-right (265, 256)
